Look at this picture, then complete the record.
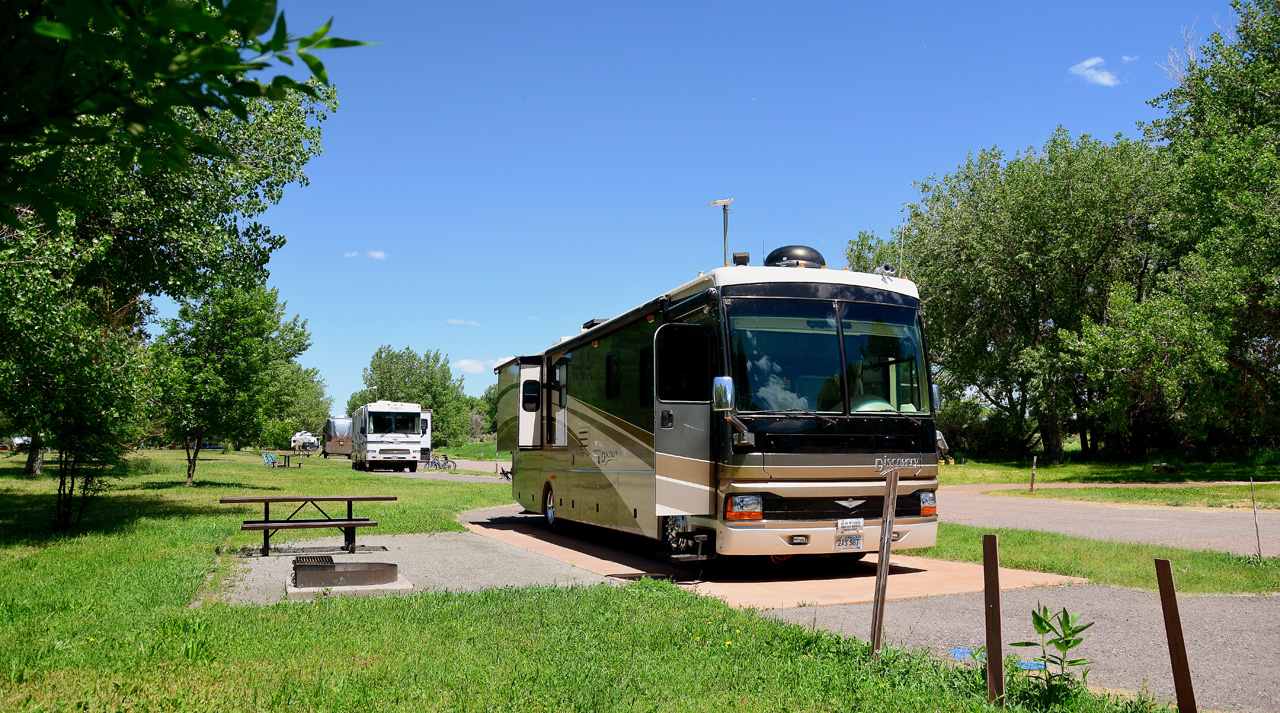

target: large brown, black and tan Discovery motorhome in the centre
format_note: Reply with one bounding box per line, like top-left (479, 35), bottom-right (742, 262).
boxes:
top-left (494, 246), bottom-right (938, 559)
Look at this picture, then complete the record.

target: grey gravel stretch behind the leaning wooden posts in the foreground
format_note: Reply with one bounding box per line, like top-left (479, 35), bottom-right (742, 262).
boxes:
top-left (764, 585), bottom-right (1280, 713)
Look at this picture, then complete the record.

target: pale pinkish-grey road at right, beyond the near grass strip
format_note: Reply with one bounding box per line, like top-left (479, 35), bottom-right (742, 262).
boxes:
top-left (938, 488), bottom-right (1280, 557)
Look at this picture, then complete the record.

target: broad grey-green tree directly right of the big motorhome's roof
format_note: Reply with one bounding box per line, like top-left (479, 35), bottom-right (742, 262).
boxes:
top-left (899, 128), bottom-right (1170, 460)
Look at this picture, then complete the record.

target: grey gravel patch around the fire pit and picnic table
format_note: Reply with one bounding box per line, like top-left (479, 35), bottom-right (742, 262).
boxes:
top-left (227, 533), bottom-right (612, 604)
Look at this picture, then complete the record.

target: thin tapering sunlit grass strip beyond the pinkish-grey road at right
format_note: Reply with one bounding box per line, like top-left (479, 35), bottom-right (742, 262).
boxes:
top-left (992, 483), bottom-right (1280, 509)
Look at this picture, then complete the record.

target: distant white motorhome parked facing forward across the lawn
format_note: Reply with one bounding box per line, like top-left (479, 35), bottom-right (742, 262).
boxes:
top-left (351, 401), bottom-right (422, 472)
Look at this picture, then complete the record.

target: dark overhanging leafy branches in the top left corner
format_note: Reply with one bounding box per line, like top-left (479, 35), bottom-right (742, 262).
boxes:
top-left (0, 0), bottom-right (361, 225)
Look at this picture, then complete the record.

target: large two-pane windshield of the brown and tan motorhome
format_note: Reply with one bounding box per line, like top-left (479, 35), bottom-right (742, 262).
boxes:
top-left (726, 298), bottom-right (929, 413)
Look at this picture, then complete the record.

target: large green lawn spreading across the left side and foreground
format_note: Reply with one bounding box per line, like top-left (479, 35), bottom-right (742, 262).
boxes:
top-left (0, 453), bottom-right (1148, 712)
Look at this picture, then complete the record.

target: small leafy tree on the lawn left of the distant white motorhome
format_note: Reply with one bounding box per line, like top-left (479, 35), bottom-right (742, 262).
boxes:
top-left (155, 285), bottom-right (311, 485)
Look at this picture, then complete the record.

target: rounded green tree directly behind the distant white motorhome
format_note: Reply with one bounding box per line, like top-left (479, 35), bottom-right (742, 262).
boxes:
top-left (347, 344), bottom-right (471, 445)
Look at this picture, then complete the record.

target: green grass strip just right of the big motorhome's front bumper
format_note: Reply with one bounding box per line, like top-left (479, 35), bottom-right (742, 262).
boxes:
top-left (910, 522), bottom-right (1280, 594)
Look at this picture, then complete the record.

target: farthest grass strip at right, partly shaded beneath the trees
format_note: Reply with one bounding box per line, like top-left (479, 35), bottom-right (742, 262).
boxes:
top-left (938, 461), bottom-right (1280, 485)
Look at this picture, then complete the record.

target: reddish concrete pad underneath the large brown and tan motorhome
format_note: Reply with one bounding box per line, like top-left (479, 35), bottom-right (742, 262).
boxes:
top-left (463, 506), bottom-right (1087, 608)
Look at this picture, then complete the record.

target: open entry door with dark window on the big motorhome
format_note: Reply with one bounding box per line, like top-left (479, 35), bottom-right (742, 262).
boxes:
top-left (653, 324), bottom-right (716, 516)
